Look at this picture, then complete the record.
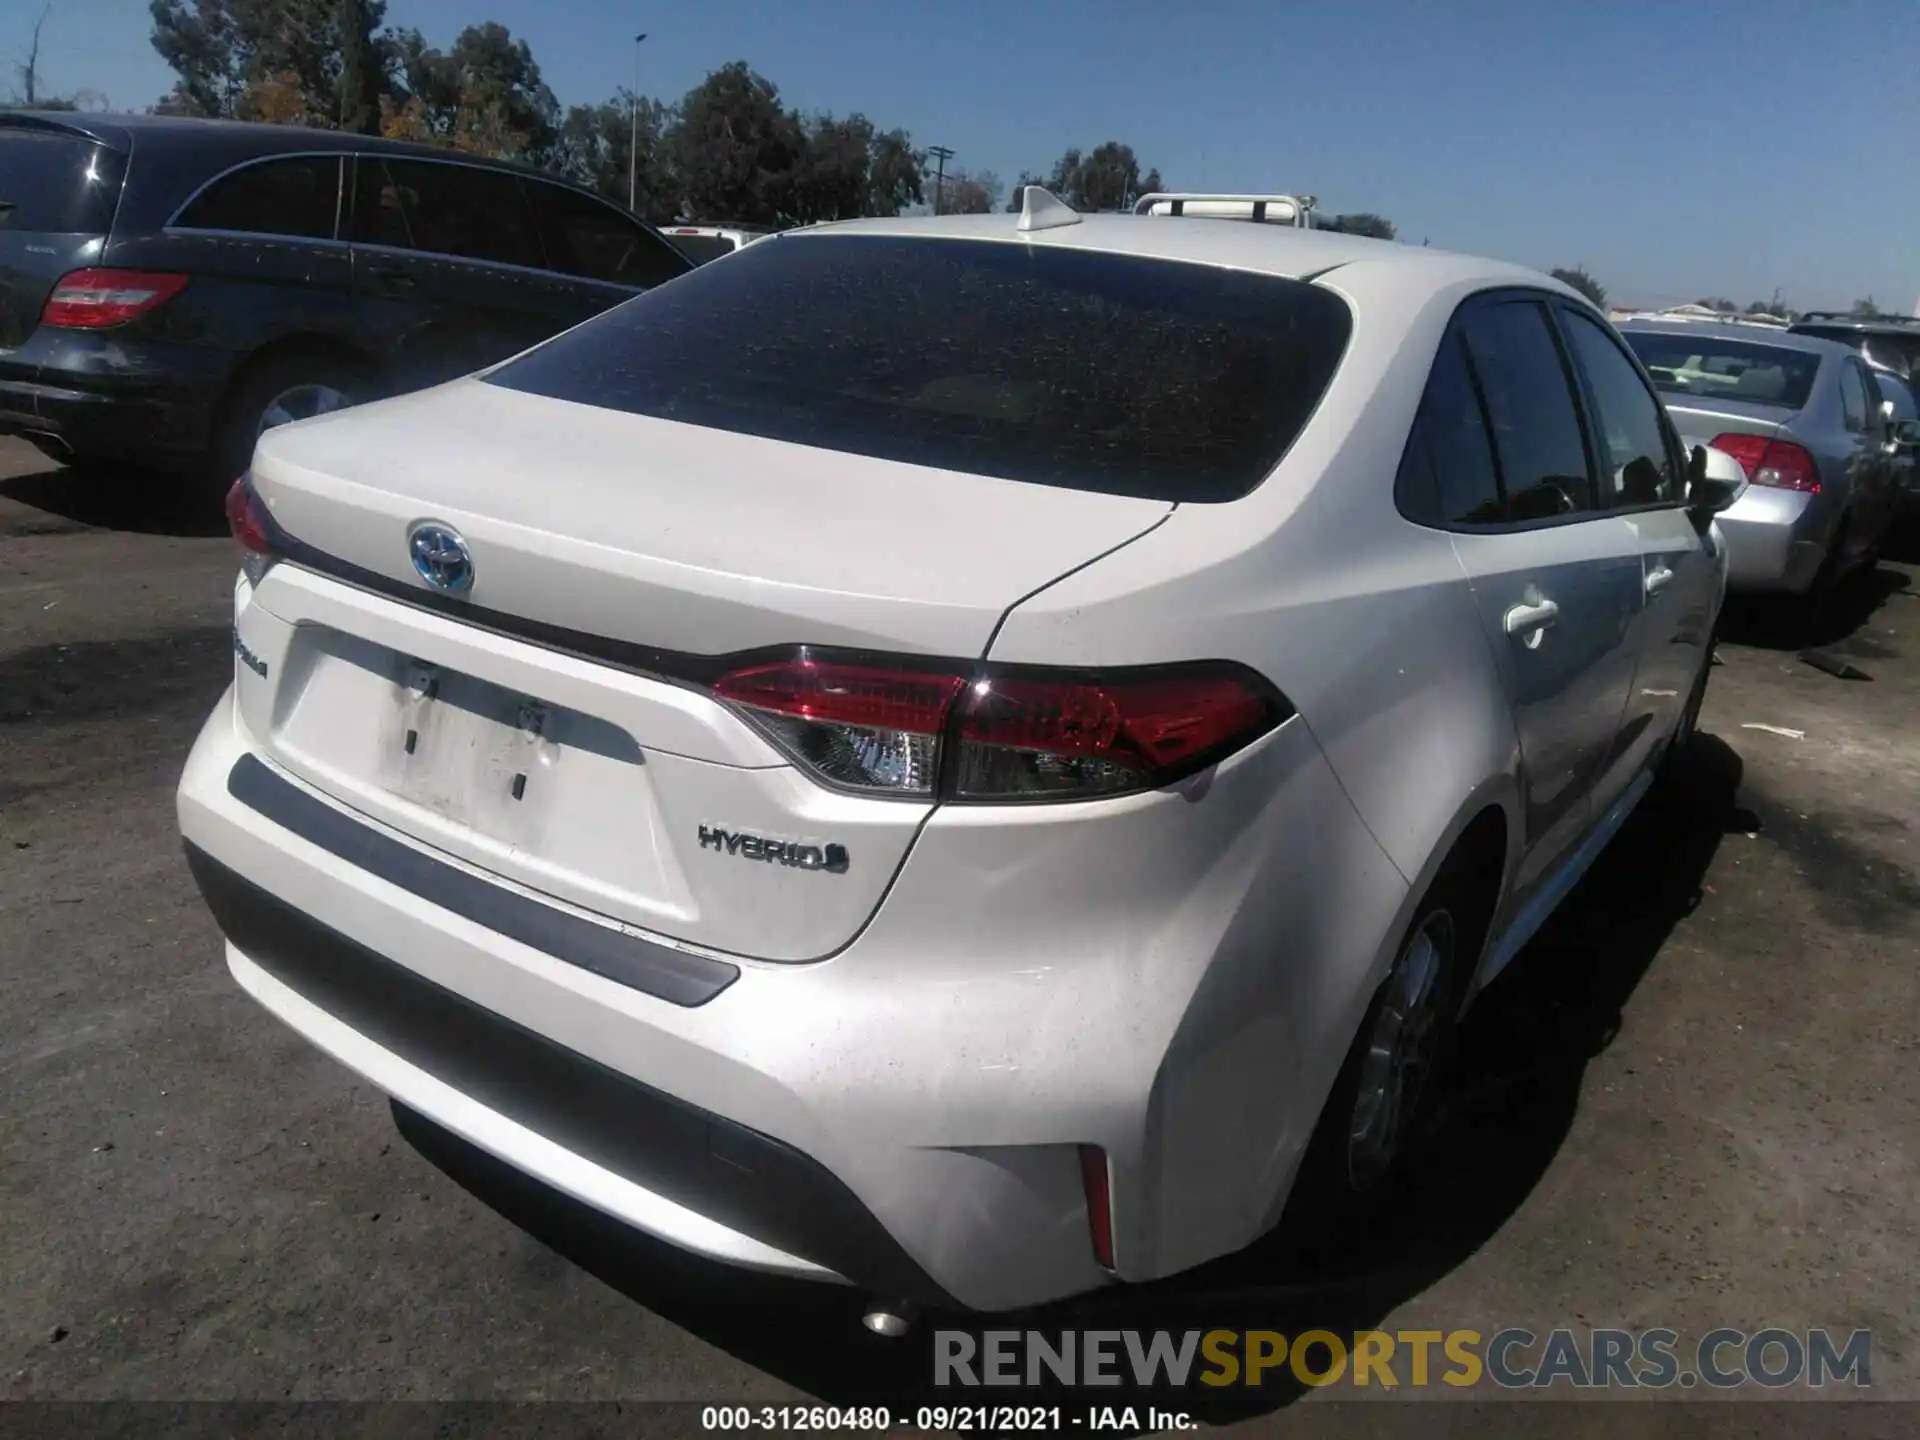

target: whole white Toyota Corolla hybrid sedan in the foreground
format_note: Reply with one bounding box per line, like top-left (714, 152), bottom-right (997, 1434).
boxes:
top-left (179, 190), bottom-right (1743, 1311)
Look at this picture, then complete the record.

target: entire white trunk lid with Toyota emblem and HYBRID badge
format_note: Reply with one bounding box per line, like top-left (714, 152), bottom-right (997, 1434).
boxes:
top-left (236, 380), bottom-right (1171, 960)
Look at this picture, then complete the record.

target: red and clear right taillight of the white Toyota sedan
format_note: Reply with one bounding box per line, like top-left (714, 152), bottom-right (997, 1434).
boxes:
top-left (714, 655), bottom-right (1292, 803)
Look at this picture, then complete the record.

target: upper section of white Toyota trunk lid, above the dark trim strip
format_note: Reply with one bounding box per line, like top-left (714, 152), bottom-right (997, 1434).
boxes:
top-left (243, 380), bottom-right (1171, 657)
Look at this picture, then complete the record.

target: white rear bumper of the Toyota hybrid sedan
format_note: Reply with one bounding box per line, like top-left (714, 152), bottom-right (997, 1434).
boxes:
top-left (179, 672), bottom-right (1411, 1309)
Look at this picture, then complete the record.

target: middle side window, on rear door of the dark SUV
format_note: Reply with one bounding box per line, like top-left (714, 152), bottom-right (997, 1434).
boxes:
top-left (353, 156), bottom-right (547, 269)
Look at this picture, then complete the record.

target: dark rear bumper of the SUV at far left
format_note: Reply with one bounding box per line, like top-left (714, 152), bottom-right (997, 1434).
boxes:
top-left (0, 326), bottom-right (234, 465)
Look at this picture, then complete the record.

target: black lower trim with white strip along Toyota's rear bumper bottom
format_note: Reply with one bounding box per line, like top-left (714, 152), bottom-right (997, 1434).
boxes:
top-left (186, 845), bottom-right (952, 1306)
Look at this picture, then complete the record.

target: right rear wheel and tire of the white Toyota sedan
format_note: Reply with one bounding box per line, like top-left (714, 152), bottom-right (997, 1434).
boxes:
top-left (1288, 856), bottom-right (1488, 1225)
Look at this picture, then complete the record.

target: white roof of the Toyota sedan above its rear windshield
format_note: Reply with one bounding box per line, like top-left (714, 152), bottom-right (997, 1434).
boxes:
top-left (774, 213), bottom-right (1584, 303)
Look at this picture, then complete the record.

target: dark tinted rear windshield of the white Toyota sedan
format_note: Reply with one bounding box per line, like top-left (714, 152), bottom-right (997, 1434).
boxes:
top-left (488, 234), bottom-right (1352, 501)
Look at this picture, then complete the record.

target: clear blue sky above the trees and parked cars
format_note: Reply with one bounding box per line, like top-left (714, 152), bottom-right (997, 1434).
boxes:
top-left (15, 0), bottom-right (1920, 311)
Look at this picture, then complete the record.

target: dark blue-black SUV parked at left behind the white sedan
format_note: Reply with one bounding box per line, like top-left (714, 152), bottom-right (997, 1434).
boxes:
top-left (0, 111), bottom-right (693, 480)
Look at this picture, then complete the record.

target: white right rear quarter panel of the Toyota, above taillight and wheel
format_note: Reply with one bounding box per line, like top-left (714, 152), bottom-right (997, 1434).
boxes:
top-left (993, 263), bottom-right (1517, 906)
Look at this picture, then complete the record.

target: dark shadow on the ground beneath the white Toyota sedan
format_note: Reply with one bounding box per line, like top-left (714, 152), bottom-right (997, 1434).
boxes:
top-left (396, 733), bottom-right (1757, 1423)
